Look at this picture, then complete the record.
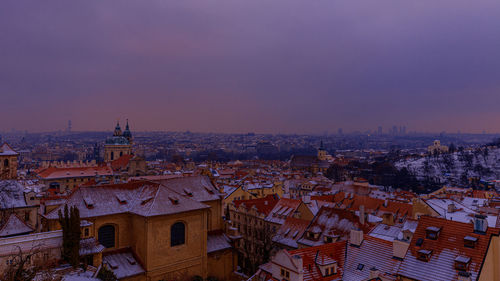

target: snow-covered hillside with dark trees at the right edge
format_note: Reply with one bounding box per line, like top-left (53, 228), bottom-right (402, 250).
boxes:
top-left (395, 147), bottom-right (500, 184)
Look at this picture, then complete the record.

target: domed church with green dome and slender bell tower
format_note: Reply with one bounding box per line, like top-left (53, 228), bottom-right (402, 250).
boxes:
top-left (104, 120), bottom-right (132, 162)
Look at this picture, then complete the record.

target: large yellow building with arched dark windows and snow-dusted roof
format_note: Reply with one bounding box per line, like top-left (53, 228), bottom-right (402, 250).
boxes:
top-left (45, 177), bottom-right (237, 281)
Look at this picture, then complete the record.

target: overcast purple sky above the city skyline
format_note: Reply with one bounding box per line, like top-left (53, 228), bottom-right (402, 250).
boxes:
top-left (0, 0), bottom-right (500, 133)
